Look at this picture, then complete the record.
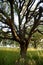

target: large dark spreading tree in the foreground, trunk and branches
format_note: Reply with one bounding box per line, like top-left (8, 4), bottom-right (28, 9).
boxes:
top-left (0, 0), bottom-right (43, 58)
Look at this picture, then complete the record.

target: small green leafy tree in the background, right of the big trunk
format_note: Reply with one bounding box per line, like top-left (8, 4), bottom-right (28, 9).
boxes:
top-left (30, 32), bottom-right (43, 48)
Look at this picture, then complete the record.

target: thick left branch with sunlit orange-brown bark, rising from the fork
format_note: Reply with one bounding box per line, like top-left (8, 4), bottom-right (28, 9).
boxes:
top-left (0, 14), bottom-right (20, 41)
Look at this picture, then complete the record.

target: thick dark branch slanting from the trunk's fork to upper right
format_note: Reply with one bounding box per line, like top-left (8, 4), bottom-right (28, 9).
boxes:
top-left (27, 4), bottom-right (42, 45)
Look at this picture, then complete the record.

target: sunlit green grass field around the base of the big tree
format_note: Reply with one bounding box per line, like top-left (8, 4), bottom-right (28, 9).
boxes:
top-left (0, 48), bottom-right (43, 65)
